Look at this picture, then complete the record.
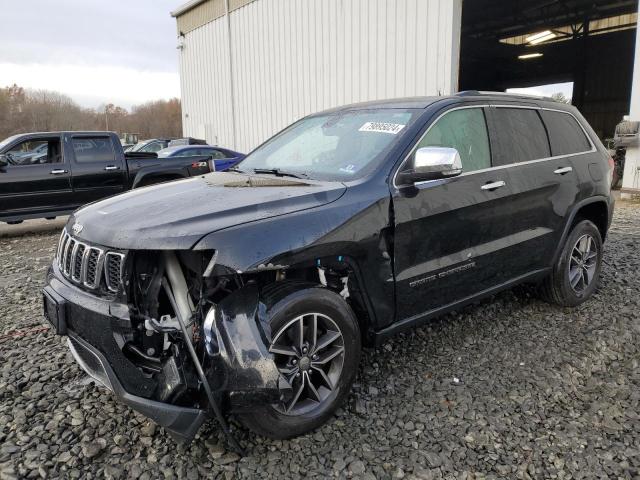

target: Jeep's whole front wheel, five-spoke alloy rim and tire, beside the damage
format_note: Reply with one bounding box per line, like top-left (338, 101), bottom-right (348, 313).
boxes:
top-left (239, 286), bottom-right (361, 439)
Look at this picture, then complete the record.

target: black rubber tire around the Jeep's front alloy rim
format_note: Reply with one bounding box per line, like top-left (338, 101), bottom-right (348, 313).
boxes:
top-left (239, 285), bottom-right (361, 439)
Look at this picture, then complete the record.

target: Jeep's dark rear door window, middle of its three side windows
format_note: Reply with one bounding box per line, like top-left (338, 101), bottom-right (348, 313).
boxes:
top-left (492, 107), bottom-right (551, 165)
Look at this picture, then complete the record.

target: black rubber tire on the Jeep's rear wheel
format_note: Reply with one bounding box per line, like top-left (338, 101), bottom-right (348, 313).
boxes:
top-left (540, 220), bottom-right (602, 307)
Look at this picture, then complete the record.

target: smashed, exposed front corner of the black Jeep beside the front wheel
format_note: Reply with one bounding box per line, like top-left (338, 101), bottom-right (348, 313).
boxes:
top-left (125, 251), bottom-right (282, 411)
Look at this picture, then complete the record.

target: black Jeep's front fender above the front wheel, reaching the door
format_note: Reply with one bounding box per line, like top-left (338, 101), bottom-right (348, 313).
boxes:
top-left (194, 189), bottom-right (395, 328)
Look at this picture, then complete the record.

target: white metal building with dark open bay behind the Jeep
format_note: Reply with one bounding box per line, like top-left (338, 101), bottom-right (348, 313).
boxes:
top-left (172, 0), bottom-right (640, 194)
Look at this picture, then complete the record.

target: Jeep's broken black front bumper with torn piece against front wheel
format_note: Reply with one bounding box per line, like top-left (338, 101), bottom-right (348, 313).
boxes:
top-left (42, 263), bottom-right (280, 441)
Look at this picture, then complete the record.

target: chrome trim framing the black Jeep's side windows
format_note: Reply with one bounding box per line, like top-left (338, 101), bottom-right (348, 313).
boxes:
top-left (392, 104), bottom-right (597, 190)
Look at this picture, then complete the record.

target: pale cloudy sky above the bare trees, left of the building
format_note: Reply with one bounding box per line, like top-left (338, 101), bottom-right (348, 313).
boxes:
top-left (0, 0), bottom-right (183, 108)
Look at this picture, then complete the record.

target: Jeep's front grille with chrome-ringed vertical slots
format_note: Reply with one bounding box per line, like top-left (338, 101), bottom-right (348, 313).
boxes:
top-left (57, 230), bottom-right (124, 292)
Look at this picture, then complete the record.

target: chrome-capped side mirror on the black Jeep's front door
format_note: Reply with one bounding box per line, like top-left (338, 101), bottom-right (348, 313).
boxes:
top-left (398, 147), bottom-right (462, 185)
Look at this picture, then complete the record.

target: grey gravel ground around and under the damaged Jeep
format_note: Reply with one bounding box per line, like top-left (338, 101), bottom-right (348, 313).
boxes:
top-left (0, 203), bottom-right (640, 479)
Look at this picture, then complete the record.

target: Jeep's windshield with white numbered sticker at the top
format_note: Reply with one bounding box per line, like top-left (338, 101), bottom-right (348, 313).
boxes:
top-left (237, 109), bottom-right (420, 181)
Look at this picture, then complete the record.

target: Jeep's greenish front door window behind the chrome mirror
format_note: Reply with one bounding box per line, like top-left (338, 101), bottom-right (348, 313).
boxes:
top-left (416, 108), bottom-right (491, 172)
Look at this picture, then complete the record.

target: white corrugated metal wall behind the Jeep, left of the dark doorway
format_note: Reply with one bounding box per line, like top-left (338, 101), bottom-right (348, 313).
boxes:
top-left (181, 0), bottom-right (461, 151)
